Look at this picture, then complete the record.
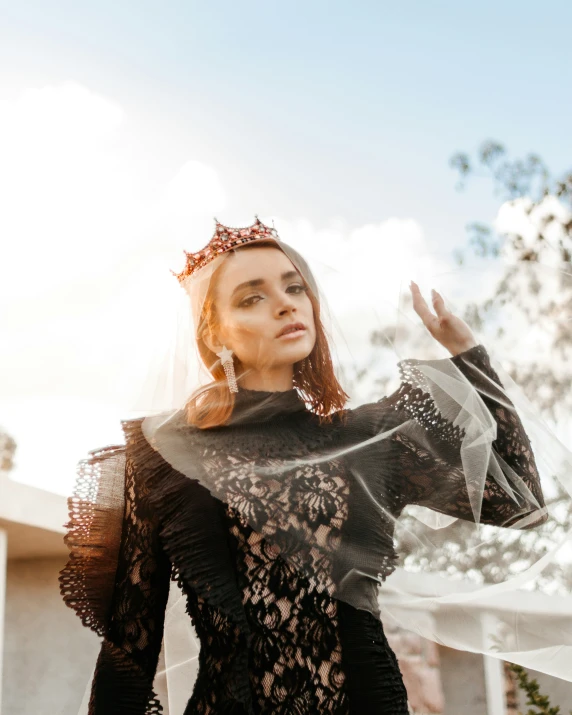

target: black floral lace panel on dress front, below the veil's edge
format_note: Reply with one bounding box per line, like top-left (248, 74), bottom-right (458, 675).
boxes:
top-left (228, 505), bottom-right (349, 715)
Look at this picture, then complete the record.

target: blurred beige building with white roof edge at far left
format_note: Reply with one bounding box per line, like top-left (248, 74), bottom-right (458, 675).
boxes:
top-left (0, 432), bottom-right (99, 715)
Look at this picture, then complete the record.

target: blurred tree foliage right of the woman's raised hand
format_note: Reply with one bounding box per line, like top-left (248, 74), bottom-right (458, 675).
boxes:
top-left (450, 139), bottom-right (572, 421)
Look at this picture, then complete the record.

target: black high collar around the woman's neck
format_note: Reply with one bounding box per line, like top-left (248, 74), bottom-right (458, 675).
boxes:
top-left (227, 386), bottom-right (307, 425)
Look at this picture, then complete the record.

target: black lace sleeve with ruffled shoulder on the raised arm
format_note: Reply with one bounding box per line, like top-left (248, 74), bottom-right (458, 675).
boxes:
top-left (380, 345), bottom-right (548, 529)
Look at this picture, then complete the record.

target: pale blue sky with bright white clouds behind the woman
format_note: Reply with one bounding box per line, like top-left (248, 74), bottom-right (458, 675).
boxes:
top-left (0, 0), bottom-right (572, 493)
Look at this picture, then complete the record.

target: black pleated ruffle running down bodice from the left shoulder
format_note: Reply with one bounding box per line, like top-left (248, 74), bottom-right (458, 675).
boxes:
top-left (122, 420), bottom-right (254, 715)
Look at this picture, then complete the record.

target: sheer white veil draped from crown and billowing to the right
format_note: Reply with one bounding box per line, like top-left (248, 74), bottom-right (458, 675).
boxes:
top-left (65, 225), bottom-right (572, 715)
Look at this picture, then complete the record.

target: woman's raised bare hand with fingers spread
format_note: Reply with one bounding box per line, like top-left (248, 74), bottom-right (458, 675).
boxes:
top-left (409, 281), bottom-right (478, 355)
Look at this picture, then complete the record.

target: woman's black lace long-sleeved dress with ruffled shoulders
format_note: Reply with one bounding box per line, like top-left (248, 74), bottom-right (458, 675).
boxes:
top-left (60, 346), bottom-right (543, 715)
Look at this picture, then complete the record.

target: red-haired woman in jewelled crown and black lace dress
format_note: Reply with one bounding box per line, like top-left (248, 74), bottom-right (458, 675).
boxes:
top-left (60, 219), bottom-right (546, 715)
